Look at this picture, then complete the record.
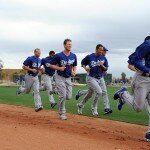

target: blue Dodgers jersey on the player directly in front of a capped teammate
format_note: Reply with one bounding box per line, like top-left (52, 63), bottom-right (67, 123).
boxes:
top-left (81, 53), bottom-right (108, 79)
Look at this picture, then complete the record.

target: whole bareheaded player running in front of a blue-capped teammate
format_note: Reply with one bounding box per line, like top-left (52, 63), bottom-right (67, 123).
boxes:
top-left (77, 44), bottom-right (108, 116)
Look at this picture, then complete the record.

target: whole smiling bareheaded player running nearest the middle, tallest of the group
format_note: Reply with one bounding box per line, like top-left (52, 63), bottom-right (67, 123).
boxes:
top-left (51, 39), bottom-right (77, 120)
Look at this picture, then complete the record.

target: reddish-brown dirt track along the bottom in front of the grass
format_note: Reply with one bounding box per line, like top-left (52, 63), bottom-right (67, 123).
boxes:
top-left (0, 104), bottom-right (150, 150)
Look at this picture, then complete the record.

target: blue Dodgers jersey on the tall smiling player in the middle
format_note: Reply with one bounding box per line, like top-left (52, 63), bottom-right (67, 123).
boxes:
top-left (52, 52), bottom-right (77, 78)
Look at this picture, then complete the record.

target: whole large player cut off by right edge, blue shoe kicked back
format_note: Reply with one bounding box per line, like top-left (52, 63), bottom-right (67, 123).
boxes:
top-left (114, 36), bottom-right (150, 141)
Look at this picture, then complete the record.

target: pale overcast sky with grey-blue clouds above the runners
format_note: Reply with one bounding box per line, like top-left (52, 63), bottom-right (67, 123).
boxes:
top-left (0, 0), bottom-right (150, 76)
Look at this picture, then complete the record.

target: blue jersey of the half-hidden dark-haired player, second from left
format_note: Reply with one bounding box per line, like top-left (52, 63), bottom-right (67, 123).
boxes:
top-left (42, 56), bottom-right (55, 76)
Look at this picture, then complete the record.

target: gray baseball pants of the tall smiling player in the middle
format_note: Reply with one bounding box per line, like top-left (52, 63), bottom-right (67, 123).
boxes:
top-left (55, 74), bottom-right (72, 115)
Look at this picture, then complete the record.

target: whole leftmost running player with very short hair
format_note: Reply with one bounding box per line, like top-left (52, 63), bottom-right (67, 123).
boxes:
top-left (16, 48), bottom-right (43, 112)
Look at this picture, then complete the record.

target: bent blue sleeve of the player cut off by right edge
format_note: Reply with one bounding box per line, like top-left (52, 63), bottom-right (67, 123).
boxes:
top-left (135, 45), bottom-right (150, 73)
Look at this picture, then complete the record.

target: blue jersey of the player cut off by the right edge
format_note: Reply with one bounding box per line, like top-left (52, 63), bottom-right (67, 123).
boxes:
top-left (134, 40), bottom-right (150, 73)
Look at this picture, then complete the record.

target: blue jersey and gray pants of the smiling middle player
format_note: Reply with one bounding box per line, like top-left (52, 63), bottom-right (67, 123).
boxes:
top-left (51, 52), bottom-right (77, 116)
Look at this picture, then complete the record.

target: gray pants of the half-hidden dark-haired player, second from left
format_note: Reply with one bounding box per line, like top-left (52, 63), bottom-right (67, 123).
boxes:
top-left (40, 74), bottom-right (55, 104)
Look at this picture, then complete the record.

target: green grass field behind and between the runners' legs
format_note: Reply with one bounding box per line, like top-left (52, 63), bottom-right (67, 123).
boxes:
top-left (0, 86), bottom-right (148, 125)
